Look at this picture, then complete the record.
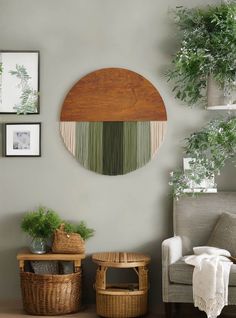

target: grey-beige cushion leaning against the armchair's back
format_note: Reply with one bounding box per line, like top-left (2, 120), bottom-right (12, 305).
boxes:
top-left (207, 213), bottom-right (236, 257)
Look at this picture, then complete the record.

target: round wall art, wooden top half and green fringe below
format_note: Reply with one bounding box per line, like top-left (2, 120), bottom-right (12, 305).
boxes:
top-left (60, 68), bottom-right (167, 175)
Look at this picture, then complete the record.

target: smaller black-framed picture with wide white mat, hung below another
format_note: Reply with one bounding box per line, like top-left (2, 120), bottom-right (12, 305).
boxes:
top-left (5, 123), bottom-right (41, 157)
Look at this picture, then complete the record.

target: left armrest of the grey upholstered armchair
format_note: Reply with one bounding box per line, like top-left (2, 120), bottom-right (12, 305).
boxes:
top-left (162, 236), bottom-right (183, 302)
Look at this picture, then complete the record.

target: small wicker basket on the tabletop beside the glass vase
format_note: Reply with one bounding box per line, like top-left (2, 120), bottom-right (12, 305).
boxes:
top-left (52, 224), bottom-right (85, 254)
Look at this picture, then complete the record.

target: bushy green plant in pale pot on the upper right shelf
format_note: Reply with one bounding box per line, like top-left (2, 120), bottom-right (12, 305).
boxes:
top-left (168, 1), bottom-right (236, 109)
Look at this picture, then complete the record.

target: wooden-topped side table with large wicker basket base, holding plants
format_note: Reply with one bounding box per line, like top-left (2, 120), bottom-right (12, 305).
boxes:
top-left (17, 249), bottom-right (85, 315)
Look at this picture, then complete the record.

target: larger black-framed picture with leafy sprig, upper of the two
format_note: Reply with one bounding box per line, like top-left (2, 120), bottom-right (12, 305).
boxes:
top-left (0, 51), bottom-right (39, 114)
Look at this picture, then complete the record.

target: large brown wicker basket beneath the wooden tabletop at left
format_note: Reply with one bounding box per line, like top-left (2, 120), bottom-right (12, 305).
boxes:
top-left (20, 271), bottom-right (81, 316)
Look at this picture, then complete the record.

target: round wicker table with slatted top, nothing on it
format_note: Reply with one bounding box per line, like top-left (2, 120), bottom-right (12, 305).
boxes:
top-left (92, 252), bottom-right (150, 318)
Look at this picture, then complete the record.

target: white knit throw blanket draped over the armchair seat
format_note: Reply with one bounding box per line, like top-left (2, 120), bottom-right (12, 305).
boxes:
top-left (185, 246), bottom-right (233, 318)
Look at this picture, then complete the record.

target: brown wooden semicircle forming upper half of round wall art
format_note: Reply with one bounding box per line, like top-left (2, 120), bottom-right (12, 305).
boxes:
top-left (60, 68), bottom-right (167, 122)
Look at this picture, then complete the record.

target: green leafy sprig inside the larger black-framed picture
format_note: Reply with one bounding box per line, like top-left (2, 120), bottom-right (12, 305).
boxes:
top-left (10, 64), bottom-right (38, 114)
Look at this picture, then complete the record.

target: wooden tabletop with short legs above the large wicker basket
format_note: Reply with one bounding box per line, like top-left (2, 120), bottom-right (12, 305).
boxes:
top-left (16, 248), bottom-right (85, 272)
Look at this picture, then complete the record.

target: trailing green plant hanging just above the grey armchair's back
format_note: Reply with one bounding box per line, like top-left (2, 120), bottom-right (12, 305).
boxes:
top-left (169, 117), bottom-right (236, 197)
